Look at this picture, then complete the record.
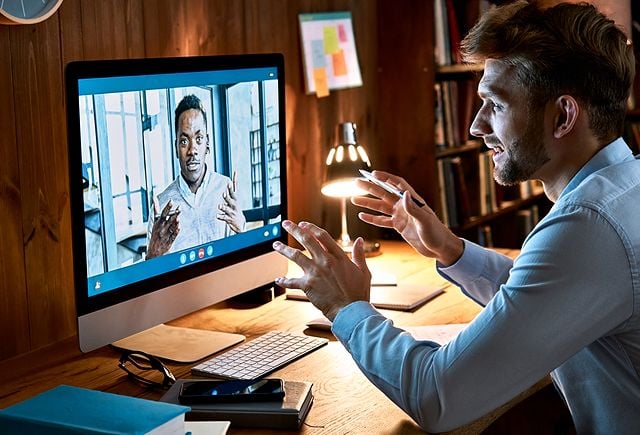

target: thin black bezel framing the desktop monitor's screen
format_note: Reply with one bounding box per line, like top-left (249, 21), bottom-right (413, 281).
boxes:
top-left (65, 53), bottom-right (287, 316)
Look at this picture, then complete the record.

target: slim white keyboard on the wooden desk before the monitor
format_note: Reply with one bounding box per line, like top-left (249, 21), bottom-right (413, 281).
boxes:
top-left (191, 331), bottom-right (329, 379)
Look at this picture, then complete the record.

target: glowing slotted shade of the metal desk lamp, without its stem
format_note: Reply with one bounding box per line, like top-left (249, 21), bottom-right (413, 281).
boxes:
top-left (322, 122), bottom-right (371, 198)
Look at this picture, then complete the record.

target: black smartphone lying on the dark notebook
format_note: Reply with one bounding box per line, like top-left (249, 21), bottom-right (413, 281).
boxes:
top-left (178, 378), bottom-right (284, 404)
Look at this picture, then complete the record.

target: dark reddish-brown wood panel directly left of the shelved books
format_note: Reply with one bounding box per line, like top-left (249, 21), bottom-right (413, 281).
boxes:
top-left (378, 0), bottom-right (437, 213)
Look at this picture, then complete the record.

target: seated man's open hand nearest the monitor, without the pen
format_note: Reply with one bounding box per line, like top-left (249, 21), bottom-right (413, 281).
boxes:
top-left (273, 220), bottom-right (371, 321)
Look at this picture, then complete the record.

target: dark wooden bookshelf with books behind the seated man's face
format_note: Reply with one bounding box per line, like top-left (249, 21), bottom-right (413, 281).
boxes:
top-left (378, 0), bottom-right (551, 248)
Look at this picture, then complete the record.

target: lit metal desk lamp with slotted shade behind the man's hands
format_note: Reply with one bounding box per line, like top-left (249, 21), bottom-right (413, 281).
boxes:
top-left (321, 122), bottom-right (380, 254)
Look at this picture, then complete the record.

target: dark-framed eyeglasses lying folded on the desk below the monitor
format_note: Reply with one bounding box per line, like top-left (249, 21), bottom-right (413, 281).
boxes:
top-left (118, 351), bottom-right (176, 388)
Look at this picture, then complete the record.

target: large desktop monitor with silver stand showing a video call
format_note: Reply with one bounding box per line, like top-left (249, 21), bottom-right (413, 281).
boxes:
top-left (65, 54), bottom-right (287, 362)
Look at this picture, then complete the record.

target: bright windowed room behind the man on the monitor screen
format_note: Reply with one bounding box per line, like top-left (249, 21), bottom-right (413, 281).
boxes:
top-left (79, 80), bottom-right (281, 277)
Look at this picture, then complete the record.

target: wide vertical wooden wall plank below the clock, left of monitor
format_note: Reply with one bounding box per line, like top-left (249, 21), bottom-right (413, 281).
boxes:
top-left (10, 15), bottom-right (75, 348)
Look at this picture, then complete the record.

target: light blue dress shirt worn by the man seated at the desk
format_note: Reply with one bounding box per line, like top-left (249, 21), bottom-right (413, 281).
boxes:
top-left (333, 139), bottom-right (640, 434)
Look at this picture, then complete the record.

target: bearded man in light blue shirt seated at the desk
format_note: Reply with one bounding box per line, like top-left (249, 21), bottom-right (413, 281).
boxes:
top-left (274, 1), bottom-right (640, 434)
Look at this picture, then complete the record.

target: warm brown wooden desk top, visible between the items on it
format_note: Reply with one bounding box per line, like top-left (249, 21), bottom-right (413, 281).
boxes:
top-left (0, 241), bottom-right (539, 434)
